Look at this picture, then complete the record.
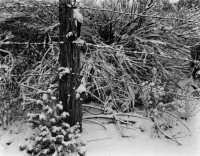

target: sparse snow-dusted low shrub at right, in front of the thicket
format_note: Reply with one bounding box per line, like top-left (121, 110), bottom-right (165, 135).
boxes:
top-left (140, 80), bottom-right (190, 144)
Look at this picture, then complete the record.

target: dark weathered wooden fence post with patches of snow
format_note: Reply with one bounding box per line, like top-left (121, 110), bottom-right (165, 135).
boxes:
top-left (59, 0), bottom-right (82, 130)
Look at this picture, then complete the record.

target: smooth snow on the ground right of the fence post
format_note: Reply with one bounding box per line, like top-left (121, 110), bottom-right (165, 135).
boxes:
top-left (83, 111), bottom-right (200, 156)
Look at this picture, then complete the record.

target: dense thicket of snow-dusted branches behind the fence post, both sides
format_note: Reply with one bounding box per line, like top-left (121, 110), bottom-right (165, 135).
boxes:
top-left (0, 0), bottom-right (199, 119)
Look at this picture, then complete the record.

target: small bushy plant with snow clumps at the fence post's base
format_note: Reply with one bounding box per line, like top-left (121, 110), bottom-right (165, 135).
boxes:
top-left (23, 89), bottom-right (86, 156)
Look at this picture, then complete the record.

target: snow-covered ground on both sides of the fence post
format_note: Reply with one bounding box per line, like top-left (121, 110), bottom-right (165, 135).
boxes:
top-left (0, 105), bottom-right (200, 156)
